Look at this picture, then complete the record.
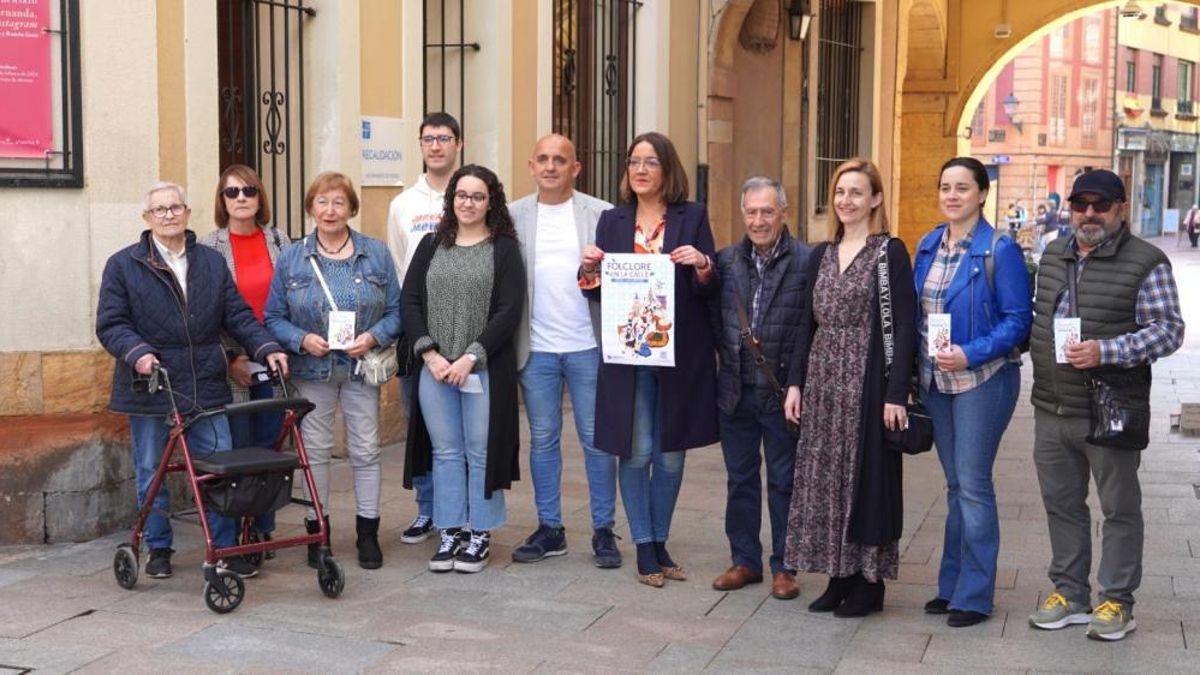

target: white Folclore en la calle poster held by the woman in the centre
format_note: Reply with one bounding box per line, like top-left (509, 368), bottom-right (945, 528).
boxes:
top-left (600, 253), bottom-right (674, 368)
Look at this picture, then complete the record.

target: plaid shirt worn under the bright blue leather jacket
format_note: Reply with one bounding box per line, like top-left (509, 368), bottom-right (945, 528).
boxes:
top-left (920, 228), bottom-right (1020, 394)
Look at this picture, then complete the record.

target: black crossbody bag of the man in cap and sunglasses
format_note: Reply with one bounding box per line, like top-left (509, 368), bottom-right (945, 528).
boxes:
top-left (1067, 261), bottom-right (1150, 450)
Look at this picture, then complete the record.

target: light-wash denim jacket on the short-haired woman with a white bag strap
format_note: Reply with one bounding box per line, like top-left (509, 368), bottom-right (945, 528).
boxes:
top-left (265, 229), bottom-right (400, 381)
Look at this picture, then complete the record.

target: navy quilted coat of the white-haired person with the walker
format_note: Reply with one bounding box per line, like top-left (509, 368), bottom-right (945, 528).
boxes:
top-left (96, 229), bottom-right (283, 414)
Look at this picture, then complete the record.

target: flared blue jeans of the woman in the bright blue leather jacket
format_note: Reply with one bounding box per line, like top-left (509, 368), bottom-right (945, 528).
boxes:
top-left (923, 364), bottom-right (1021, 614)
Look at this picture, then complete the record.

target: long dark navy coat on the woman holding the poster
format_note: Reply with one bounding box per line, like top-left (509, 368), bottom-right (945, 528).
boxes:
top-left (583, 202), bottom-right (720, 458)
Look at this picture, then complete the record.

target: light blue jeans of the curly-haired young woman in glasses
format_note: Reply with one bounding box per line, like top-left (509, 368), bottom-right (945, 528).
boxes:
top-left (419, 368), bottom-right (505, 531)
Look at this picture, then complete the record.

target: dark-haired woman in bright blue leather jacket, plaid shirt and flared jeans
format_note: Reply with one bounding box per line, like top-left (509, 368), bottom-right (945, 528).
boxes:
top-left (913, 157), bottom-right (1033, 627)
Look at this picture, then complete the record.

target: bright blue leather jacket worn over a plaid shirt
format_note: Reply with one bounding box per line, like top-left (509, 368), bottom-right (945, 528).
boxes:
top-left (913, 219), bottom-right (1033, 368)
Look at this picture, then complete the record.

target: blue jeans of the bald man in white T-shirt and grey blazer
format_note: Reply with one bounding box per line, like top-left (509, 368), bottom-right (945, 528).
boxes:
top-left (521, 348), bottom-right (617, 528)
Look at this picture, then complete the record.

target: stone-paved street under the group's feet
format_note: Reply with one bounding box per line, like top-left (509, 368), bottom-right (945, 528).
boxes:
top-left (0, 236), bottom-right (1200, 673)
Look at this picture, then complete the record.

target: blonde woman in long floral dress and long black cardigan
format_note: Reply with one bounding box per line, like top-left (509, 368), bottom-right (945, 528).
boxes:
top-left (784, 159), bottom-right (916, 616)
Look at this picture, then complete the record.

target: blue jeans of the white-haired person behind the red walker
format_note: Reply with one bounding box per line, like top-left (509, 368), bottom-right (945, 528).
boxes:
top-left (130, 414), bottom-right (238, 550)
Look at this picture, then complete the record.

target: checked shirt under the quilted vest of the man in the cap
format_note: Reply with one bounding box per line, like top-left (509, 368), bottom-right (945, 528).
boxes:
top-left (1054, 238), bottom-right (1183, 368)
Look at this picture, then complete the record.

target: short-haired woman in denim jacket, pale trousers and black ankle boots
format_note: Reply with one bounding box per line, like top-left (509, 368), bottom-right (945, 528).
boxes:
top-left (266, 172), bottom-right (400, 569)
